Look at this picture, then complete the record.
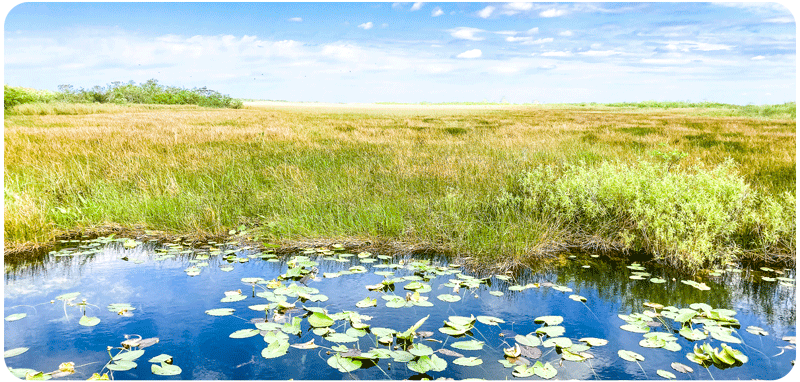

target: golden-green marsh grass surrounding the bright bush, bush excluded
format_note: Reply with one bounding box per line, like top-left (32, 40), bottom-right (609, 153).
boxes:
top-left (4, 106), bottom-right (795, 263)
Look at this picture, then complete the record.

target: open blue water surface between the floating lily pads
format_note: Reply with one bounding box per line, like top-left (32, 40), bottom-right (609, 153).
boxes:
top-left (3, 240), bottom-right (796, 380)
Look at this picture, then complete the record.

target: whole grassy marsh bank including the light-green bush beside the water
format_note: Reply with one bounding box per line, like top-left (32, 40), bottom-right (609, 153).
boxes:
top-left (4, 101), bottom-right (796, 266)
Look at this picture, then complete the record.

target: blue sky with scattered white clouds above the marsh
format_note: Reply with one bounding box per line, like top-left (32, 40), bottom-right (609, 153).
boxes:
top-left (3, 3), bottom-right (796, 104)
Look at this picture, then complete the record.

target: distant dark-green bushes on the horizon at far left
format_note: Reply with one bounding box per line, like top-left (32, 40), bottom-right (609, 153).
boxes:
top-left (3, 79), bottom-right (242, 114)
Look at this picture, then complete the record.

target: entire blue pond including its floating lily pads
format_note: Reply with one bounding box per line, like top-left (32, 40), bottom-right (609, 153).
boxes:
top-left (3, 237), bottom-right (796, 380)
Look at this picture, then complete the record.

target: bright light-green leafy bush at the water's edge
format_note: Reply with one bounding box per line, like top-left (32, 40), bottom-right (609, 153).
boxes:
top-left (499, 160), bottom-right (795, 268)
